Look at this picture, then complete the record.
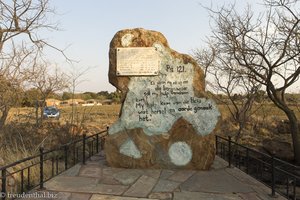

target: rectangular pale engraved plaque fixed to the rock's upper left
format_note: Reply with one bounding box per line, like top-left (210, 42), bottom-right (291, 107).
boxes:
top-left (117, 47), bottom-right (160, 76)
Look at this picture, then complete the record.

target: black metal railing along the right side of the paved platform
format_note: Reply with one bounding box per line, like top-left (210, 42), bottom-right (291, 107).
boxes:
top-left (216, 136), bottom-right (300, 199)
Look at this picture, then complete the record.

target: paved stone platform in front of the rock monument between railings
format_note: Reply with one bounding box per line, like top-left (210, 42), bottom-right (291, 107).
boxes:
top-left (33, 153), bottom-right (285, 200)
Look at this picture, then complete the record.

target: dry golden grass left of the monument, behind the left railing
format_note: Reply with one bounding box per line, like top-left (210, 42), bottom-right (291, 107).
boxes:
top-left (0, 105), bottom-right (120, 166)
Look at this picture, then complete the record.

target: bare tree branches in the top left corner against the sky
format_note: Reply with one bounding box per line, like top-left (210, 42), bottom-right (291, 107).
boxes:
top-left (0, 0), bottom-right (68, 56)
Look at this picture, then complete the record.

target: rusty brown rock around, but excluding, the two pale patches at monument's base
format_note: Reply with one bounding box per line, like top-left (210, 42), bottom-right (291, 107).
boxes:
top-left (105, 119), bottom-right (215, 170)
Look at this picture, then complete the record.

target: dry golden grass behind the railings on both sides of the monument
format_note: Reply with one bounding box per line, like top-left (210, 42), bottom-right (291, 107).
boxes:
top-left (0, 104), bottom-right (300, 165)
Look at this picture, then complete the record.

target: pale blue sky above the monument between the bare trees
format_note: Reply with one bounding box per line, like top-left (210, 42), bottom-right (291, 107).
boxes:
top-left (43, 0), bottom-right (260, 92)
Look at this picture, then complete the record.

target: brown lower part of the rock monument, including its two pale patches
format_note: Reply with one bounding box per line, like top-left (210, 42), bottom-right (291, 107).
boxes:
top-left (105, 118), bottom-right (215, 170)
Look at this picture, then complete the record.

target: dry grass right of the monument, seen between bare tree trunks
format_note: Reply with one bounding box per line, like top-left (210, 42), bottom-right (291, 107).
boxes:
top-left (218, 103), bottom-right (300, 148)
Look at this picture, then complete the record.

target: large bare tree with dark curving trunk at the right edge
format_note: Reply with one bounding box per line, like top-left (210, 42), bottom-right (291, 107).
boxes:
top-left (209, 0), bottom-right (300, 163)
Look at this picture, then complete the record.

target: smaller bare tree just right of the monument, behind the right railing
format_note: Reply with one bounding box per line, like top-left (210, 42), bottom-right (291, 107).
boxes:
top-left (194, 46), bottom-right (260, 141)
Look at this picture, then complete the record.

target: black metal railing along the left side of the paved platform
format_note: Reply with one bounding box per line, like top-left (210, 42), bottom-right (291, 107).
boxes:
top-left (0, 128), bottom-right (108, 199)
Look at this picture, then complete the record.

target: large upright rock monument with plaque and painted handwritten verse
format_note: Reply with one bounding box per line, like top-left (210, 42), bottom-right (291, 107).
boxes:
top-left (105, 29), bottom-right (220, 170)
